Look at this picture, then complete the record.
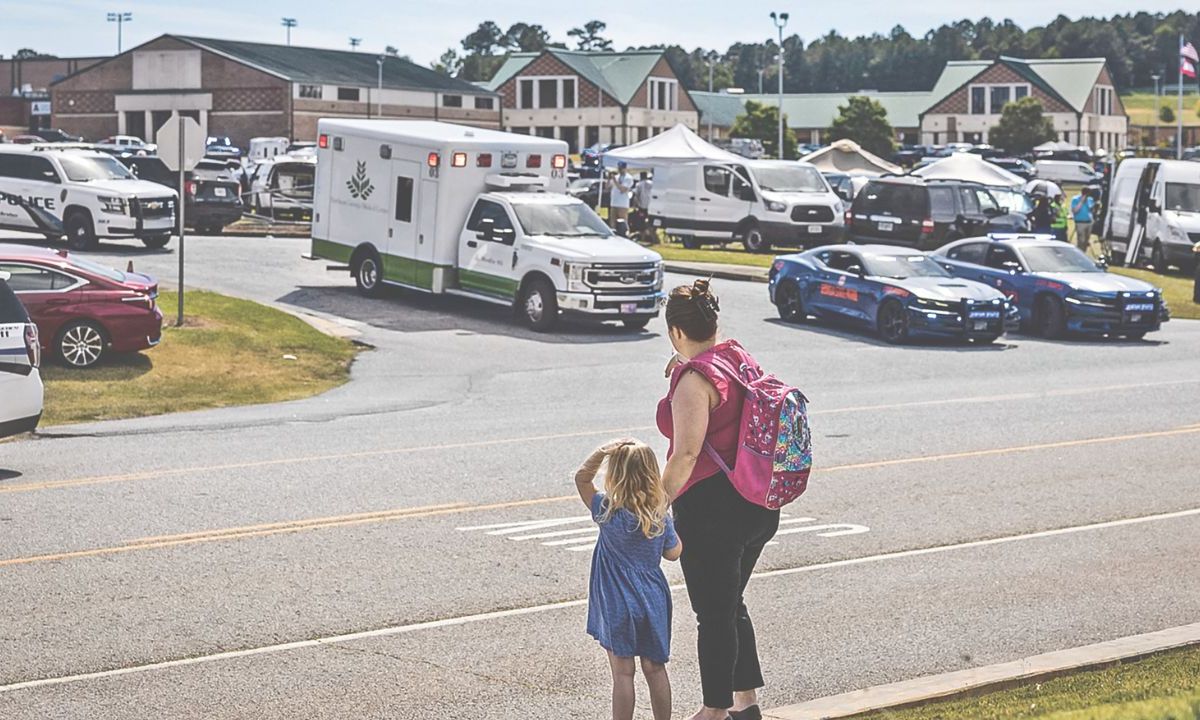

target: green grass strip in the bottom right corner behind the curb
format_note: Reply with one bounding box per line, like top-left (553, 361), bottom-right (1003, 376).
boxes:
top-left (854, 647), bottom-right (1200, 720)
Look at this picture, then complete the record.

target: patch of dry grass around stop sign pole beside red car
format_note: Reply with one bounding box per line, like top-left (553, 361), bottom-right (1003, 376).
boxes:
top-left (42, 290), bottom-right (358, 426)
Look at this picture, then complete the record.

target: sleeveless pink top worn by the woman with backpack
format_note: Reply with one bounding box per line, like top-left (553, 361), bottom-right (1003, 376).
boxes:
top-left (656, 340), bottom-right (758, 496)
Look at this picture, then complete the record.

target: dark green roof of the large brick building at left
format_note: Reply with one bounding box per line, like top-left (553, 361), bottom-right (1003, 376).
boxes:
top-left (168, 35), bottom-right (486, 95)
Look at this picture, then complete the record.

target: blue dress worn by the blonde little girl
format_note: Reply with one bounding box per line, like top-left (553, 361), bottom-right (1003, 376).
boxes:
top-left (588, 493), bottom-right (679, 662)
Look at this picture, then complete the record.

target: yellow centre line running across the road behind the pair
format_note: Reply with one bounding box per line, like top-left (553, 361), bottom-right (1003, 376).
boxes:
top-left (0, 426), bottom-right (1200, 568)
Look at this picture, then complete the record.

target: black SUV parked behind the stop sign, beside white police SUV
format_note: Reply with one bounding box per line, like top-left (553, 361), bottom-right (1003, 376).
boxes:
top-left (120, 156), bottom-right (245, 235)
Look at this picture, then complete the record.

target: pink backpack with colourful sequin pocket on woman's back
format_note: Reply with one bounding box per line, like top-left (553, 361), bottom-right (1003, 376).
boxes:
top-left (704, 350), bottom-right (812, 510)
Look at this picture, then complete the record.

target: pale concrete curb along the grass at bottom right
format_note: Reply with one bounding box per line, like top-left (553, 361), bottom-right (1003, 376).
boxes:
top-left (763, 623), bottom-right (1200, 720)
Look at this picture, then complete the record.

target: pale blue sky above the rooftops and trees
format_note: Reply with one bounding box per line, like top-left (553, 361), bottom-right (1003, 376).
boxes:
top-left (0, 0), bottom-right (1195, 62)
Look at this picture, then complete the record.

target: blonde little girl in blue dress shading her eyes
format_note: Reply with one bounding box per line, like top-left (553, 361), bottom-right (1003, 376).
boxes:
top-left (575, 440), bottom-right (683, 720)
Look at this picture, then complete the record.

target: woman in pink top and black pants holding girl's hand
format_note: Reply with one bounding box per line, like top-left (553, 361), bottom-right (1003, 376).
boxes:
top-left (656, 280), bottom-right (779, 720)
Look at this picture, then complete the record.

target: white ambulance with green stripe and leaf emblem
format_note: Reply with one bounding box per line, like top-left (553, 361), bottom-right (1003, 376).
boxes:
top-left (312, 119), bottom-right (662, 331)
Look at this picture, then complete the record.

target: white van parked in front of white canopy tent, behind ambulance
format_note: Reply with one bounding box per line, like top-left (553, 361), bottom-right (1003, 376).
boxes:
top-left (649, 160), bottom-right (846, 252)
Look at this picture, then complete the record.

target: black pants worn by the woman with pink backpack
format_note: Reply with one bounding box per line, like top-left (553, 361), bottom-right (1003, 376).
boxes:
top-left (673, 473), bottom-right (779, 708)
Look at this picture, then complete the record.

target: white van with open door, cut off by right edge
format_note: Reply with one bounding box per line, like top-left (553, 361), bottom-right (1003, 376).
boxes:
top-left (1103, 157), bottom-right (1200, 271)
